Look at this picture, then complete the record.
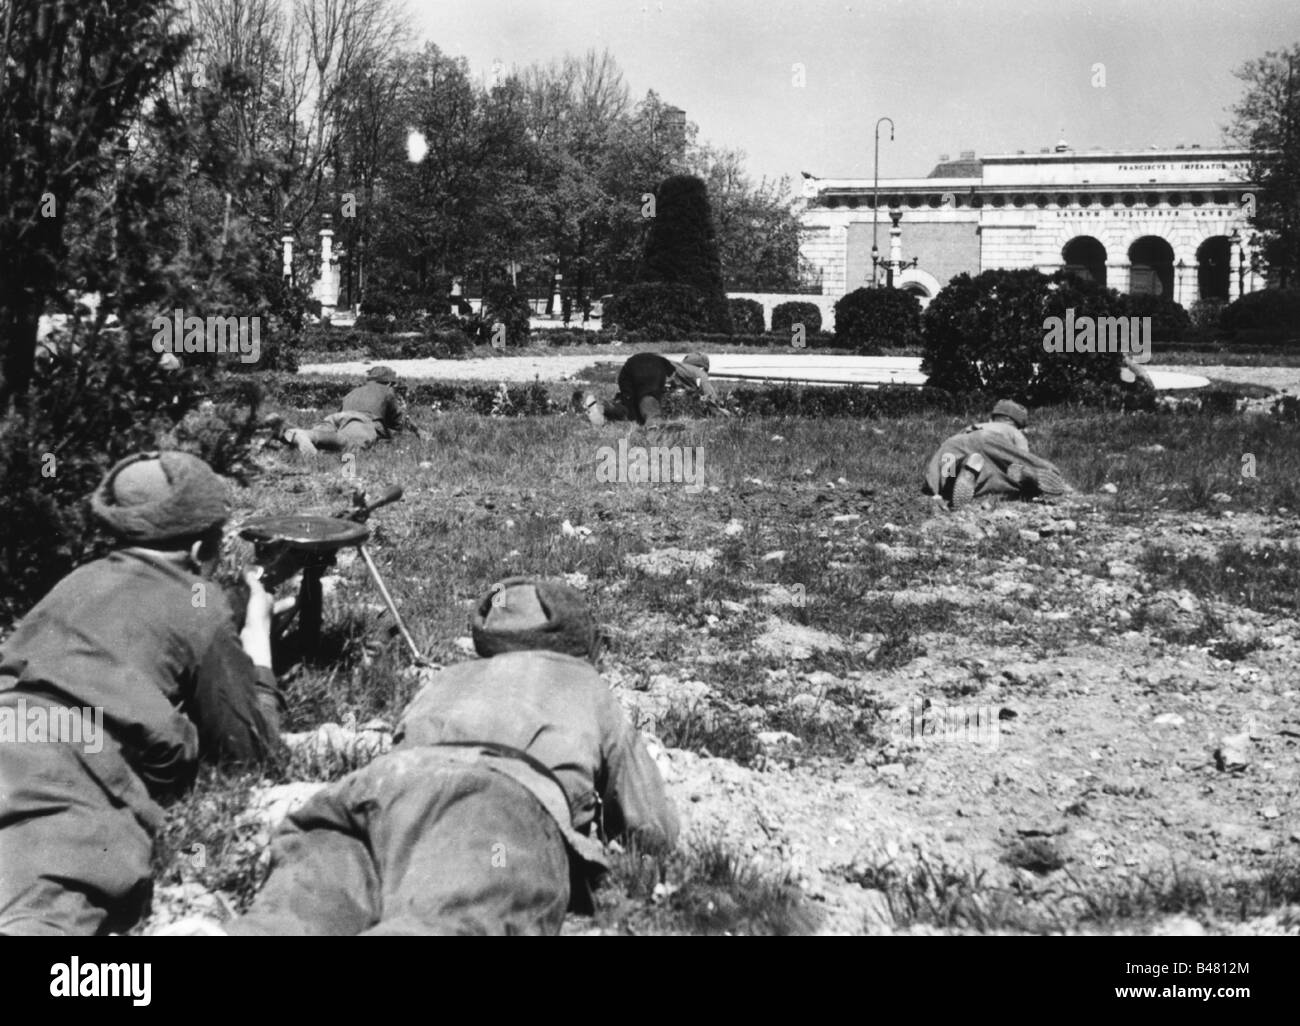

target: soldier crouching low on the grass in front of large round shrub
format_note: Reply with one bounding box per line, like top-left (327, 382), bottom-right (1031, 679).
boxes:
top-left (922, 399), bottom-right (1066, 510)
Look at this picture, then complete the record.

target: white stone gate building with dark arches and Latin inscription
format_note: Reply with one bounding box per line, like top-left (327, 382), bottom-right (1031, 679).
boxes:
top-left (801, 142), bottom-right (1264, 307)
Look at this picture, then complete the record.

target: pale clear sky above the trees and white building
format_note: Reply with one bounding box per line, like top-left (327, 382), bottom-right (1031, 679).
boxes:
top-left (406, 0), bottom-right (1300, 189)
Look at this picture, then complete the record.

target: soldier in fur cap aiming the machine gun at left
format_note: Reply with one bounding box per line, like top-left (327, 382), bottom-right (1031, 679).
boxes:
top-left (0, 453), bottom-right (282, 935)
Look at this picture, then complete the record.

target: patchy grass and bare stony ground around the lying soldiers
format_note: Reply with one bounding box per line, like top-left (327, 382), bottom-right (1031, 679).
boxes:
top-left (142, 400), bottom-right (1300, 934)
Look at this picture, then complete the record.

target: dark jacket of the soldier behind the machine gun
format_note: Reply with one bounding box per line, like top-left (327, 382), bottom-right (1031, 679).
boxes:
top-left (0, 549), bottom-right (282, 811)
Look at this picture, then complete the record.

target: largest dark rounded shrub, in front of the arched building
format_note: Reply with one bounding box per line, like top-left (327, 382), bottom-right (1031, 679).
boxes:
top-left (922, 269), bottom-right (1143, 404)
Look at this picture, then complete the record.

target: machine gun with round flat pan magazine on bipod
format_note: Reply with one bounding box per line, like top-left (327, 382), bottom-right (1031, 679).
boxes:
top-left (239, 485), bottom-right (426, 666)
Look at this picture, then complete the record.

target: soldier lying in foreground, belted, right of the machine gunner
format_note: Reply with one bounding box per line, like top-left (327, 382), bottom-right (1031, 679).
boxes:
top-left (161, 577), bottom-right (679, 935)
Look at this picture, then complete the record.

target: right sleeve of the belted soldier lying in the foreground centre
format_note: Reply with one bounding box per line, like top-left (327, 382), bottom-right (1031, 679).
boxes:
top-left (598, 691), bottom-right (681, 852)
